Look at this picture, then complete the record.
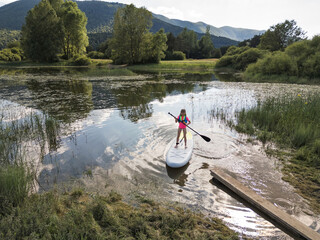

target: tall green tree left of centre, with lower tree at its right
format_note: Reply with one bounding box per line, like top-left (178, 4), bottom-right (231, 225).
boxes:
top-left (110, 4), bottom-right (152, 64)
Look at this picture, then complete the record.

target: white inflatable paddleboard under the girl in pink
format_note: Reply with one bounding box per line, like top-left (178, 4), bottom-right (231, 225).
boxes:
top-left (166, 132), bottom-right (193, 168)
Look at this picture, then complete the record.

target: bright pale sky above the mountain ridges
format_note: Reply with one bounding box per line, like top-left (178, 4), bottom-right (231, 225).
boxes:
top-left (0, 0), bottom-right (320, 37)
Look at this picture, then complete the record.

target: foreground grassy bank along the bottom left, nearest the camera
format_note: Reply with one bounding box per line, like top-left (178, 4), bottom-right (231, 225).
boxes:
top-left (0, 190), bottom-right (239, 240)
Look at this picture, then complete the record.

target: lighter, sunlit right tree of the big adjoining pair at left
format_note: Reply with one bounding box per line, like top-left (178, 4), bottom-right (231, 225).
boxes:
top-left (60, 1), bottom-right (89, 59)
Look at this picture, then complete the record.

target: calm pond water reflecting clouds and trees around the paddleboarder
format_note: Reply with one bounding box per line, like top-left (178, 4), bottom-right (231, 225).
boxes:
top-left (0, 68), bottom-right (320, 239)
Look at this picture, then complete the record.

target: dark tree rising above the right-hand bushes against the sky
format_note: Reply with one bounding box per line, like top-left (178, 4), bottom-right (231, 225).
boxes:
top-left (259, 20), bottom-right (306, 51)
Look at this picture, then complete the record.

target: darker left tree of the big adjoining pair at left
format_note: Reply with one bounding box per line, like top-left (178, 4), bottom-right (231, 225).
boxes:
top-left (21, 0), bottom-right (64, 62)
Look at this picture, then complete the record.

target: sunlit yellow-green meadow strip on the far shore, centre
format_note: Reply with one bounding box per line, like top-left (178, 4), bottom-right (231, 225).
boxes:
top-left (128, 59), bottom-right (217, 72)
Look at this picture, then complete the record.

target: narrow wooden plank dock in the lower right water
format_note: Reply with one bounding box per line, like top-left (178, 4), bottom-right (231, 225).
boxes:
top-left (211, 168), bottom-right (320, 240)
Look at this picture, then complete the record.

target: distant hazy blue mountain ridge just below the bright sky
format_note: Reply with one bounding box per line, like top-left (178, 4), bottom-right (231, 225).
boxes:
top-left (153, 14), bottom-right (265, 41)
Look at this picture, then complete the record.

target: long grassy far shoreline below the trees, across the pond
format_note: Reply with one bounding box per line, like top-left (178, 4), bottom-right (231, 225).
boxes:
top-left (0, 59), bottom-right (217, 77)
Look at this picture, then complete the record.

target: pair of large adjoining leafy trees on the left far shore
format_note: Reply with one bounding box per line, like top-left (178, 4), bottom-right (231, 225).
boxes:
top-left (21, 0), bottom-right (89, 62)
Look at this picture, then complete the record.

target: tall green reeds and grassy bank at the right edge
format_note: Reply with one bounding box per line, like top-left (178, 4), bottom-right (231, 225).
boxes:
top-left (235, 94), bottom-right (320, 212)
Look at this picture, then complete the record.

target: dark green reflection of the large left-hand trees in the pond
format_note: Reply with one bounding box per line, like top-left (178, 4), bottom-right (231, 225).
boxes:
top-left (27, 80), bottom-right (93, 123)
